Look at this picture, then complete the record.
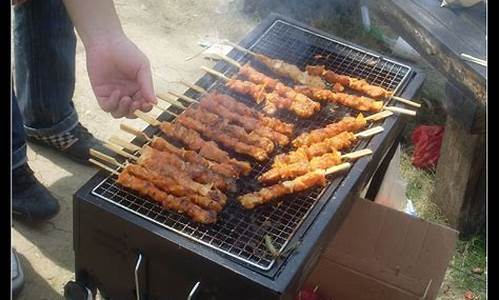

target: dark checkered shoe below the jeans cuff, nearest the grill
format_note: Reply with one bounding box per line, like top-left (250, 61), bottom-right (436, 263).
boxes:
top-left (27, 123), bottom-right (110, 165)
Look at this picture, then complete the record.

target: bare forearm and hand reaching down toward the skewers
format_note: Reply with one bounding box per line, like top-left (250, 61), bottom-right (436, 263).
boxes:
top-left (63, 0), bottom-right (156, 118)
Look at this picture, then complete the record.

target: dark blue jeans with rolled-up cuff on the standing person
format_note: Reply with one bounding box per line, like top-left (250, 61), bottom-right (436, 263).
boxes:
top-left (12, 0), bottom-right (78, 168)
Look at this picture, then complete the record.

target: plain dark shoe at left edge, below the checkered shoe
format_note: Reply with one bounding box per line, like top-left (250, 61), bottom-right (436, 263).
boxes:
top-left (12, 164), bottom-right (59, 221)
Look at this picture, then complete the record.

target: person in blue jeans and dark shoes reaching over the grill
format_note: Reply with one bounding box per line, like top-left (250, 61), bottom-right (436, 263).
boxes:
top-left (11, 0), bottom-right (156, 294)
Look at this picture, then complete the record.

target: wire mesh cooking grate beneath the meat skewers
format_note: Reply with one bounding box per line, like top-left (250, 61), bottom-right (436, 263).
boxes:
top-left (92, 21), bottom-right (411, 270)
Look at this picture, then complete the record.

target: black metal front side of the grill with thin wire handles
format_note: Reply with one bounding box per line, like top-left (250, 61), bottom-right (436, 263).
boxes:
top-left (74, 194), bottom-right (280, 300)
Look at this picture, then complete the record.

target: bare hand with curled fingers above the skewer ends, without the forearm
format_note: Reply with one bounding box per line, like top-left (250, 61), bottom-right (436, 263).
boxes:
top-left (86, 37), bottom-right (156, 118)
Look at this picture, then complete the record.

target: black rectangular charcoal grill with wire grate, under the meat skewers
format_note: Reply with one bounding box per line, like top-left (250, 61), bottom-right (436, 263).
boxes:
top-left (68, 15), bottom-right (423, 300)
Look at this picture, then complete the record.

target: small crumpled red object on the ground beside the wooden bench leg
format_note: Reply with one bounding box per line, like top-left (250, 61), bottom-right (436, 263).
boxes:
top-left (411, 125), bottom-right (444, 169)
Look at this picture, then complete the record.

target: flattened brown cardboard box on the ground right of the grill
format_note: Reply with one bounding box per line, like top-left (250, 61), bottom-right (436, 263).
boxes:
top-left (307, 199), bottom-right (458, 300)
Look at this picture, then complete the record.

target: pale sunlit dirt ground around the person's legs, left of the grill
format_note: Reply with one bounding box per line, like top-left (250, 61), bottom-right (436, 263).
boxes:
top-left (12, 0), bottom-right (256, 300)
